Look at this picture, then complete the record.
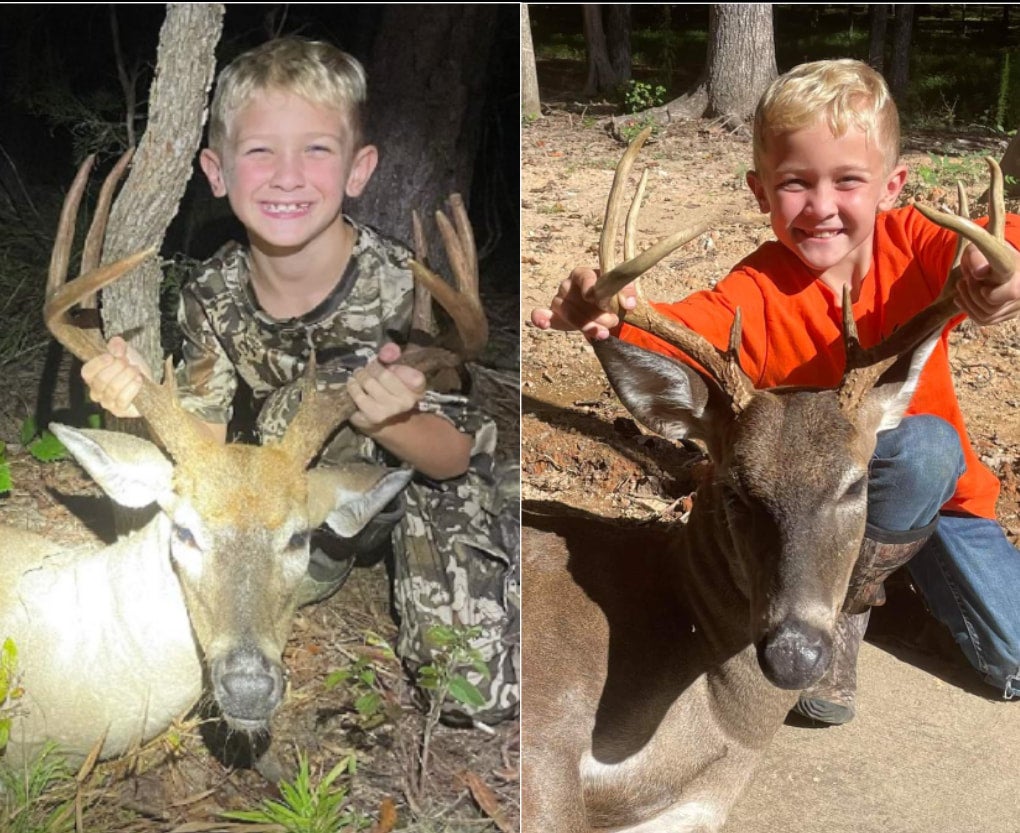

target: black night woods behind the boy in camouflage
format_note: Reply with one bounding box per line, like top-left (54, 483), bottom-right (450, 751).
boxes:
top-left (0, 3), bottom-right (519, 328)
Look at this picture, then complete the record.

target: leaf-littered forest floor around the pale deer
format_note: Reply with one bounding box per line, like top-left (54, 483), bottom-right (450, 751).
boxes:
top-left (0, 283), bottom-right (519, 833)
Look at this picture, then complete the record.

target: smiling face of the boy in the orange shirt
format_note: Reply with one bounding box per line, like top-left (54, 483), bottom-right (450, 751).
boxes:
top-left (748, 118), bottom-right (907, 287)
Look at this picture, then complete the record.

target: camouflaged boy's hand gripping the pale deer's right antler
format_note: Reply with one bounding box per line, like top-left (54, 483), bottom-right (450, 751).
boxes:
top-left (347, 344), bottom-right (425, 433)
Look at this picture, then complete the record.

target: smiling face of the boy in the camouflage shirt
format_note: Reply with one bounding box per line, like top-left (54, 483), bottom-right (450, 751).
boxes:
top-left (199, 92), bottom-right (377, 252)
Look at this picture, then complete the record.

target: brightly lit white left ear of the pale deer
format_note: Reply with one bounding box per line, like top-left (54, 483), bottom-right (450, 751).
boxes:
top-left (50, 423), bottom-right (173, 509)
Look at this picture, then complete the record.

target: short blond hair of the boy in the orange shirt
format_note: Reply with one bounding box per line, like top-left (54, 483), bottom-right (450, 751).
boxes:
top-left (754, 58), bottom-right (900, 172)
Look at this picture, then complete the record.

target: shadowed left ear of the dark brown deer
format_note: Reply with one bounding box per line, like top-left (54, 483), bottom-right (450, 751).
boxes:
top-left (592, 339), bottom-right (732, 447)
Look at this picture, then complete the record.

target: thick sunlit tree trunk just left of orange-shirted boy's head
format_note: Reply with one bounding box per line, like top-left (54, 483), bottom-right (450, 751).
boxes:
top-left (706, 3), bottom-right (777, 124)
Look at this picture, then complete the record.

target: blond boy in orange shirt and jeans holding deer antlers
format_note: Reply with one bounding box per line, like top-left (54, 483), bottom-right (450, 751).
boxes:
top-left (531, 59), bottom-right (1020, 724)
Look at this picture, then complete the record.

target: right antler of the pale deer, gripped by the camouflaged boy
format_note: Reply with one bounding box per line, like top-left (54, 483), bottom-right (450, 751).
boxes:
top-left (281, 194), bottom-right (489, 469)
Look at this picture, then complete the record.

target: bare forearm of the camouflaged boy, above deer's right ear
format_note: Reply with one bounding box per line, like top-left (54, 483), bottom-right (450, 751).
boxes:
top-left (366, 412), bottom-right (471, 480)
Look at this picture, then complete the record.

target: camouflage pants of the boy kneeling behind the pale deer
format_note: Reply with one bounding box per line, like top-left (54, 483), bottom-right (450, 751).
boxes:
top-left (258, 386), bottom-right (520, 723)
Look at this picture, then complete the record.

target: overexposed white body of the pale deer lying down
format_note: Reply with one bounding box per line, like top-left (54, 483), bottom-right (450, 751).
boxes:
top-left (0, 553), bottom-right (202, 758)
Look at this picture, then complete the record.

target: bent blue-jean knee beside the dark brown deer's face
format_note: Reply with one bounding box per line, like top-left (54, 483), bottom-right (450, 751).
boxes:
top-left (868, 414), bottom-right (966, 530)
